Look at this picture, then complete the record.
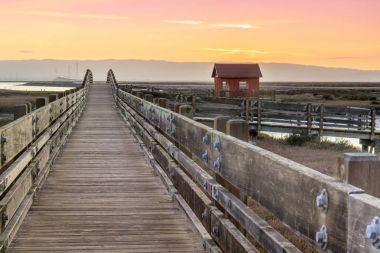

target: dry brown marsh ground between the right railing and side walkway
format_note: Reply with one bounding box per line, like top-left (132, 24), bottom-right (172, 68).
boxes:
top-left (256, 138), bottom-right (358, 177)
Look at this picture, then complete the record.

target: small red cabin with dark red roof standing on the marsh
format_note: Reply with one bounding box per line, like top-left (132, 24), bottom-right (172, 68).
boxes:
top-left (212, 63), bottom-right (262, 97)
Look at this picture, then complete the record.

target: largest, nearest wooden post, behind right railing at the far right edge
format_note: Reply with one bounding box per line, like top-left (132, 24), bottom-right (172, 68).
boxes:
top-left (343, 153), bottom-right (380, 198)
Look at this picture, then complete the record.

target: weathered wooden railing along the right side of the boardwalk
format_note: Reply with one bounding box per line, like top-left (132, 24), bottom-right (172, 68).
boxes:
top-left (109, 71), bottom-right (380, 252)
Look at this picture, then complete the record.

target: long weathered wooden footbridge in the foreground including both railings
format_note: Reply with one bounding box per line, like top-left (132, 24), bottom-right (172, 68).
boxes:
top-left (0, 71), bottom-right (380, 252)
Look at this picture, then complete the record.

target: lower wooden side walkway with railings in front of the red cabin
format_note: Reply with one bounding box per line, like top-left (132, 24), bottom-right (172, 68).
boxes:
top-left (120, 84), bottom-right (380, 148)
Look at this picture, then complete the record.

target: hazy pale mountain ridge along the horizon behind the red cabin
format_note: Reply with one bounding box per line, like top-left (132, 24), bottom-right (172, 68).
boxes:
top-left (0, 60), bottom-right (380, 82)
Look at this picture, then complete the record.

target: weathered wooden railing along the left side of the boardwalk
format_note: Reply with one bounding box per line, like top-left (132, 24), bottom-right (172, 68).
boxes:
top-left (0, 70), bottom-right (92, 250)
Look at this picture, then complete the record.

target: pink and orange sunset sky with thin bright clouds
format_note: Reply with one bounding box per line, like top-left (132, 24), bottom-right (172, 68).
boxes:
top-left (0, 0), bottom-right (380, 69)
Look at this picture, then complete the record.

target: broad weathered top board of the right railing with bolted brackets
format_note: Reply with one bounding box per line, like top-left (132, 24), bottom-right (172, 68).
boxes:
top-left (110, 69), bottom-right (380, 252)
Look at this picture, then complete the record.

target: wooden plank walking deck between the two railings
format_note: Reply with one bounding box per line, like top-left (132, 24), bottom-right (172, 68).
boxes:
top-left (9, 84), bottom-right (203, 252)
